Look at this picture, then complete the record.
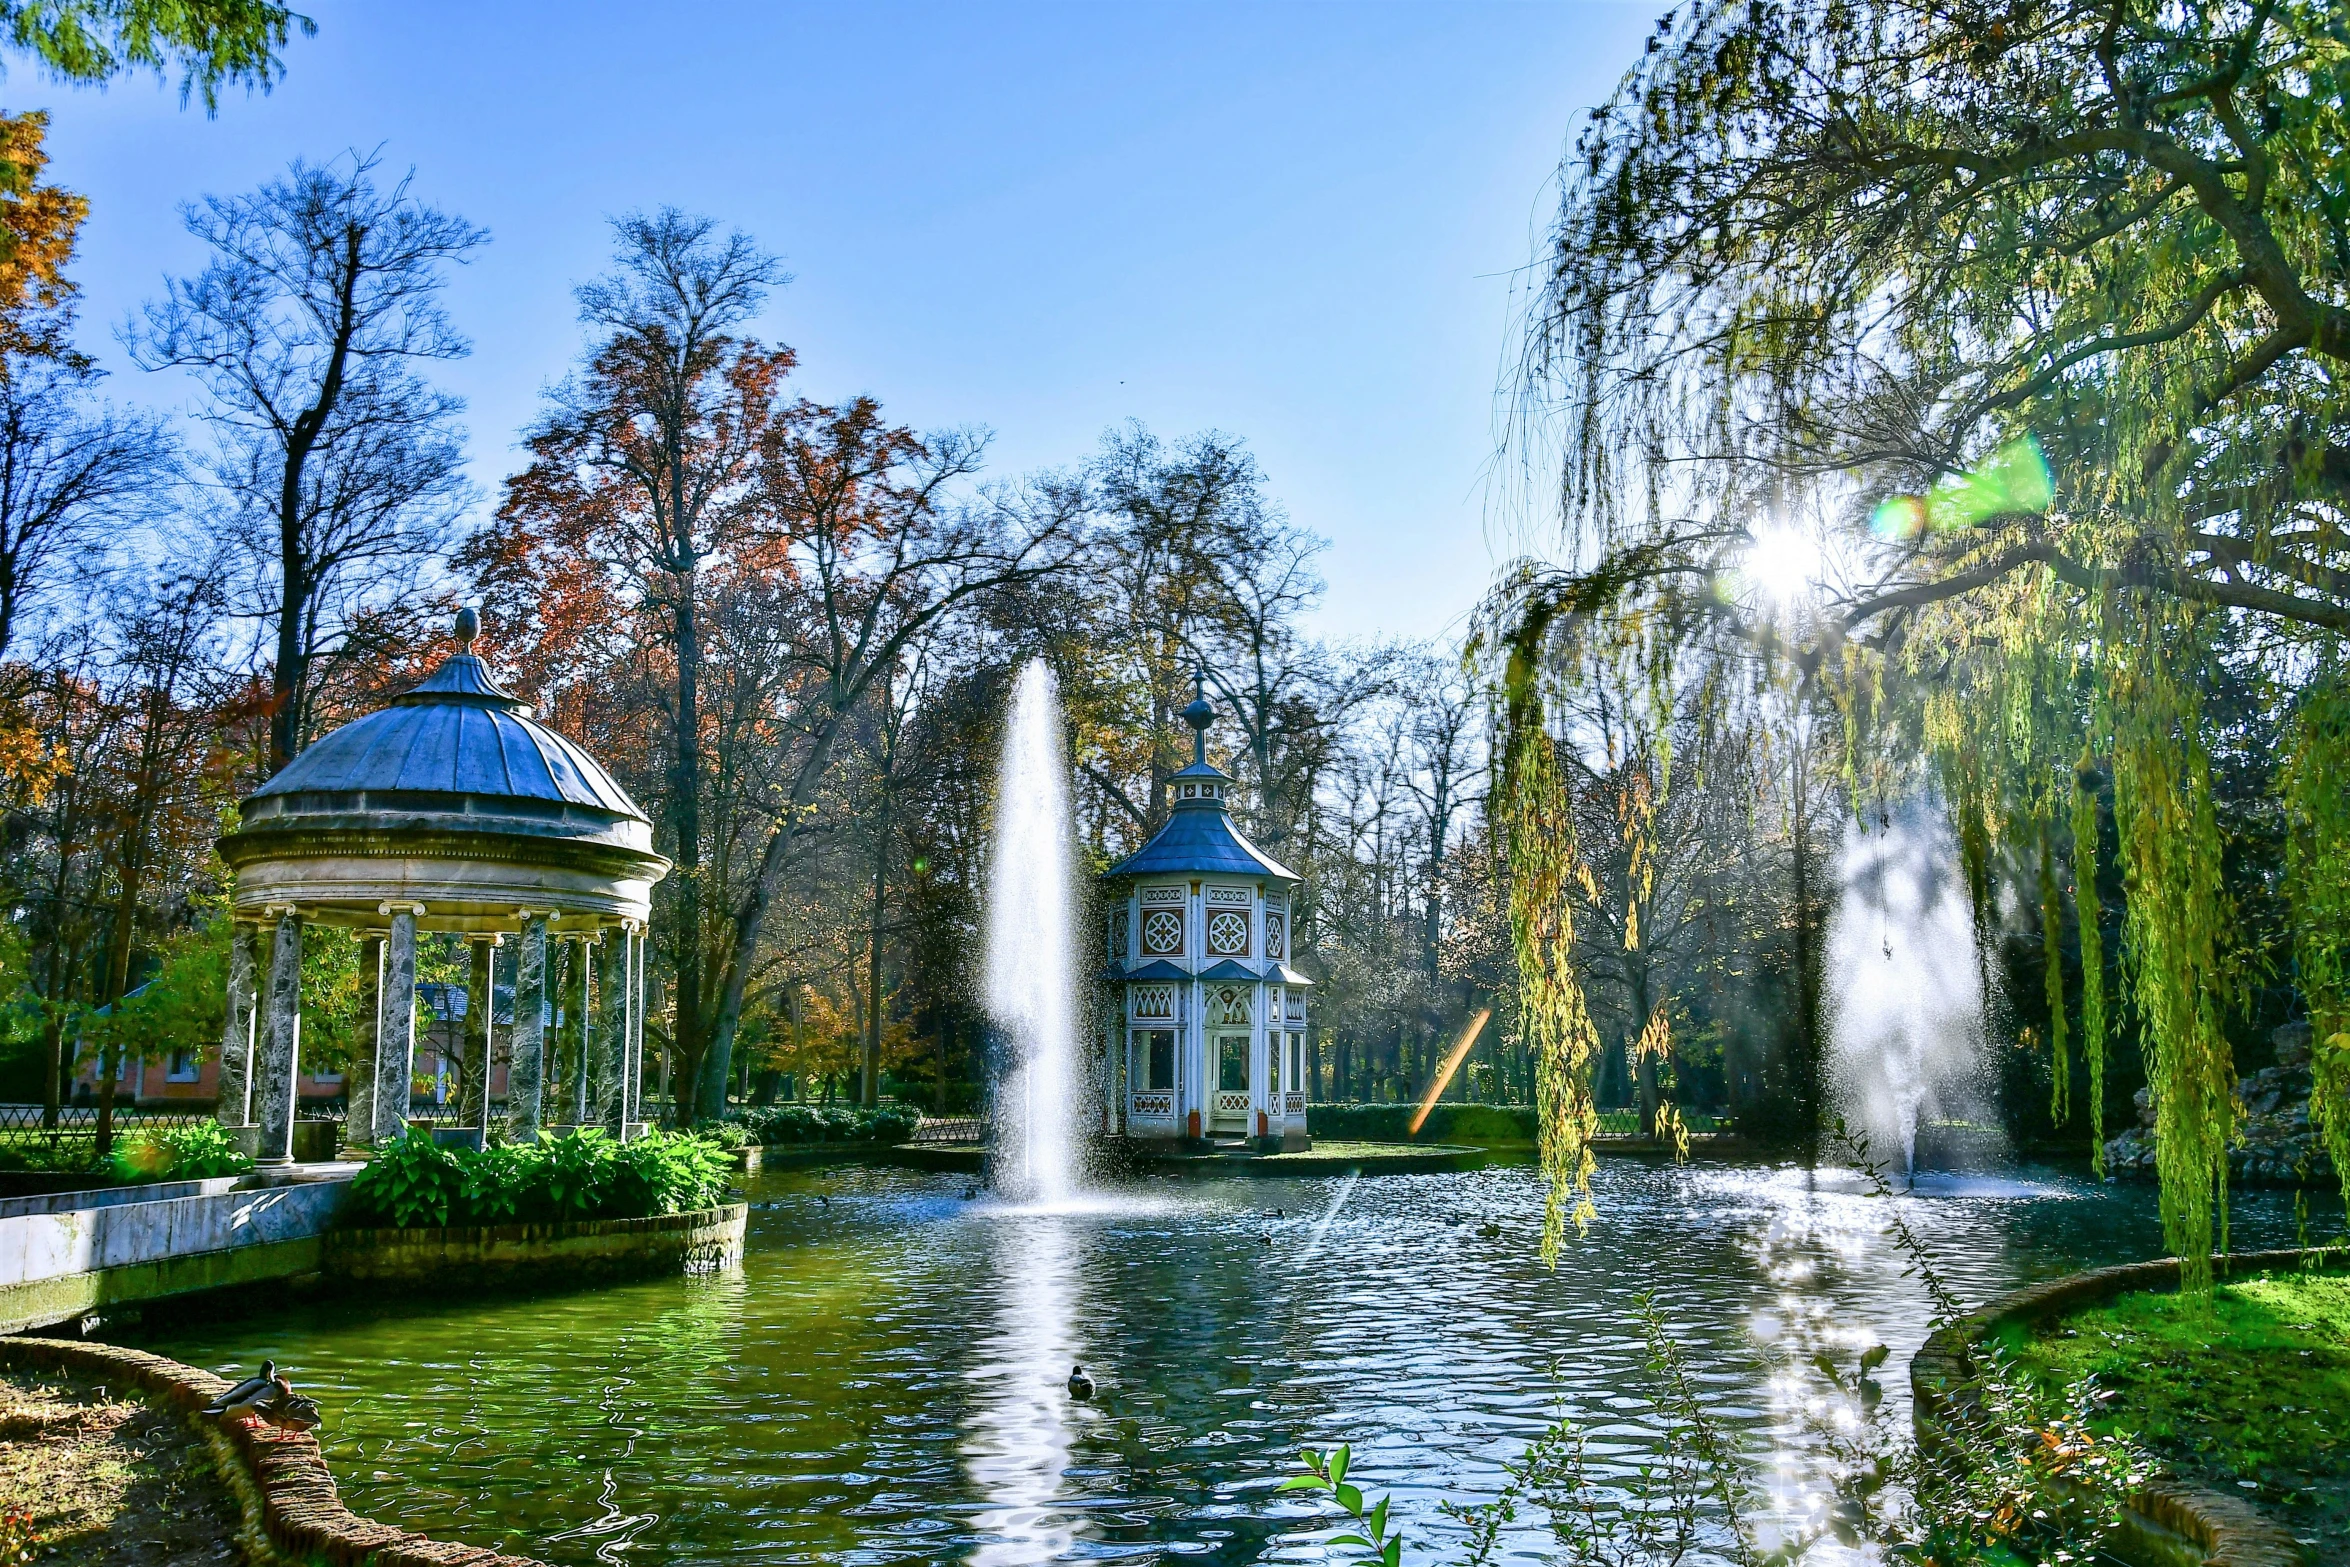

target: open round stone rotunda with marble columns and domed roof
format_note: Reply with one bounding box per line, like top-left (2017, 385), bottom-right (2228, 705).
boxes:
top-left (219, 608), bottom-right (670, 1165)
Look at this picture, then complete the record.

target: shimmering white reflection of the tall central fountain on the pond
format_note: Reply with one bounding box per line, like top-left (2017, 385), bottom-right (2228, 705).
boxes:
top-left (964, 1212), bottom-right (1083, 1567)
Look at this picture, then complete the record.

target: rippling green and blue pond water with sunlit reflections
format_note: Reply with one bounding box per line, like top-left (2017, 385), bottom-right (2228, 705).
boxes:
top-left (143, 1161), bottom-right (2294, 1567)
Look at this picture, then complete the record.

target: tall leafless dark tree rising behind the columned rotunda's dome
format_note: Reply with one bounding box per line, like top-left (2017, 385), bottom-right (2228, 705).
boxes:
top-left (129, 153), bottom-right (486, 773)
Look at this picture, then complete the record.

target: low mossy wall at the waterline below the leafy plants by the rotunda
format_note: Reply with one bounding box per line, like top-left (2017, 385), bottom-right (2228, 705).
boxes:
top-left (320, 1203), bottom-right (750, 1290)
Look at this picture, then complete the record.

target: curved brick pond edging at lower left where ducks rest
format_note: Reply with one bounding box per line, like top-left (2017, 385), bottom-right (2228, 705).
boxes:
top-left (0, 1337), bottom-right (543, 1567)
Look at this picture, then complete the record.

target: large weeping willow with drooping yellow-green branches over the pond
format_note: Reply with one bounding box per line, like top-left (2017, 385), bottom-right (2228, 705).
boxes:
top-left (1502, 0), bottom-right (2350, 1278)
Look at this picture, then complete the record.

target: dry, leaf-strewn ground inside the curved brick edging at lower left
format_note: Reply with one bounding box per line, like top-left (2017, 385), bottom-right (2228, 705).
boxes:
top-left (0, 1372), bottom-right (242, 1567)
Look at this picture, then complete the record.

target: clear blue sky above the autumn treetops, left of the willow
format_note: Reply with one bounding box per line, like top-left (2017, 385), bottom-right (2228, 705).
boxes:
top-left (32, 0), bottom-right (1654, 637)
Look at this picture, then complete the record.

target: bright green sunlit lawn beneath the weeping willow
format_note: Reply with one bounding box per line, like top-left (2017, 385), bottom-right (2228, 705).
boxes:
top-left (2007, 1271), bottom-right (2350, 1562)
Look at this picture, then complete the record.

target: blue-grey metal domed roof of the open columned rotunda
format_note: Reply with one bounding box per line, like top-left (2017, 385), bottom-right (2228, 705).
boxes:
top-left (254, 653), bottom-right (651, 822)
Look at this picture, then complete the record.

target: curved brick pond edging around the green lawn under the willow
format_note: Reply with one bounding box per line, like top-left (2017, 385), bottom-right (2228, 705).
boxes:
top-left (1911, 1247), bottom-right (2345, 1567)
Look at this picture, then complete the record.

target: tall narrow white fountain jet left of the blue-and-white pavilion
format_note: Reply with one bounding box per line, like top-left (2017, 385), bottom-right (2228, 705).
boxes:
top-left (987, 658), bottom-right (1079, 1203)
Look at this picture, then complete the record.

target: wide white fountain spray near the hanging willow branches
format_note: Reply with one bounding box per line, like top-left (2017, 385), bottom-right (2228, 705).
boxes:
top-left (1826, 799), bottom-right (1983, 1170)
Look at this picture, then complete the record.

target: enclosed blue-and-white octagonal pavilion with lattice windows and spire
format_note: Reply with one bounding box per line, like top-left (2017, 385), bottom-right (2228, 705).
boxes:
top-left (1102, 691), bottom-right (1311, 1149)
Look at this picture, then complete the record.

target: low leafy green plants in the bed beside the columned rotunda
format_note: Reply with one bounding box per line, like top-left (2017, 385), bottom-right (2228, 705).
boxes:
top-left (343, 1128), bottom-right (733, 1229)
